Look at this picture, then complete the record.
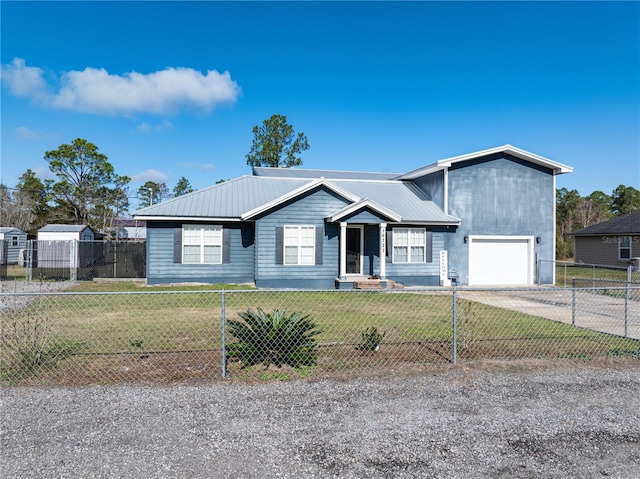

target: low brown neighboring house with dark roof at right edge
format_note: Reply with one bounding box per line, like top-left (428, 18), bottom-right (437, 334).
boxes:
top-left (569, 210), bottom-right (640, 268)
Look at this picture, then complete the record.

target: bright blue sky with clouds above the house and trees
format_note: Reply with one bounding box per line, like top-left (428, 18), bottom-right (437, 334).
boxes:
top-left (0, 1), bottom-right (640, 209)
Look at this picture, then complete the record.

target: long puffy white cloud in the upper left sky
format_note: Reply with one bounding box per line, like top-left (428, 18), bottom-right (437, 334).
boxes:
top-left (2, 58), bottom-right (241, 116)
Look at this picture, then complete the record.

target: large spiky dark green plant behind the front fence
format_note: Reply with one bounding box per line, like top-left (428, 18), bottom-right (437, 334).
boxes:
top-left (227, 308), bottom-right (321, 369)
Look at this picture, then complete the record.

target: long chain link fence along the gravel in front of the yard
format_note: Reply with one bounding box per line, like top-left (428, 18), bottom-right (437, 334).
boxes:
top-left (0, 287), bottom-right (640, 385)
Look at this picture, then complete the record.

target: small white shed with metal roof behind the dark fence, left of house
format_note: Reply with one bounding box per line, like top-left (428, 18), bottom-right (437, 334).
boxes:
top-left (33, 224), bottom-right (97, 268)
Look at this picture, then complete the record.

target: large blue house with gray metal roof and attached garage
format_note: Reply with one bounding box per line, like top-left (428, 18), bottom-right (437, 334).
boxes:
top-left (134, 145), bottom-right (572, 288)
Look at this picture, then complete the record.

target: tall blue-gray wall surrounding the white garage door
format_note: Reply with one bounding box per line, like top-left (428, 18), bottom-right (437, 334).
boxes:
top-left (445, 153), bottom-right (555, 284)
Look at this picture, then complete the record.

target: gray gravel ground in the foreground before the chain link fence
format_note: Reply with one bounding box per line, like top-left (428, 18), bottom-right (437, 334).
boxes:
top-left (0, 360), bottom-right (640, 479)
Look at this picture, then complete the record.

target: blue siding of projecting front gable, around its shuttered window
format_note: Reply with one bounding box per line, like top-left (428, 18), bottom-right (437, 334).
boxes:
top-left (255, 188), bottom-right (347, 288)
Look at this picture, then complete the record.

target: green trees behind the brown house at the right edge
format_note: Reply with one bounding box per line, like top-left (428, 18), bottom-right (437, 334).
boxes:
top-left (556, 185), bottom-right (640, 259)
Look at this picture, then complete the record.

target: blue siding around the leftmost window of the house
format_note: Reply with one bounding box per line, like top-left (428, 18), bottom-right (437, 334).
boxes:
top-left (147, 221), bottom-right (254, 284)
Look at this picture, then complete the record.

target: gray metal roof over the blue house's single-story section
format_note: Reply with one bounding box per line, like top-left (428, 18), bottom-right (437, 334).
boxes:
top-left (133, 176), bottom-right (460, 224)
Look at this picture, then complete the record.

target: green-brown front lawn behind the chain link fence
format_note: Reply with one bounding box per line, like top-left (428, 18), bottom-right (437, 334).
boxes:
top-left (0, 283), bottom-right (640, 384)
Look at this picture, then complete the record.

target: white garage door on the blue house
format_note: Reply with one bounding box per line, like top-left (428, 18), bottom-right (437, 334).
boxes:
top-left (469, 236), bottom-right (533, 285)
